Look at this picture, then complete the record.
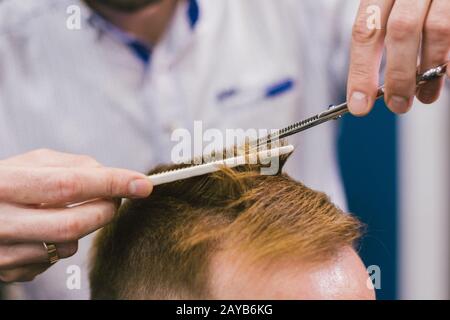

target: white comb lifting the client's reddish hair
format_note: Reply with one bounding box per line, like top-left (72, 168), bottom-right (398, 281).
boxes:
top-left (148, 145), bottom-right (294, 186)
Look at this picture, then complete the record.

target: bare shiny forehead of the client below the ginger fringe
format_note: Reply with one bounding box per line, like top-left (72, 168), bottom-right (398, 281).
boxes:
top-left (209, 247), bottom-right (375, 299)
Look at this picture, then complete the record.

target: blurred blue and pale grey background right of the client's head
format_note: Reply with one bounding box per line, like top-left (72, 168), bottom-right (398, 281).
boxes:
top-left (337, 90), bottom-right (450, 299)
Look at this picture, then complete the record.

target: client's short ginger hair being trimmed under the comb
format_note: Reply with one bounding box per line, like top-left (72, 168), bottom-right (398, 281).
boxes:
top-left (90, 157), bottom-right (360, 299)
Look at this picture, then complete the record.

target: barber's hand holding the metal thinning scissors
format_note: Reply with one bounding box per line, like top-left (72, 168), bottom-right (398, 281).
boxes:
top-left (347, 0), bottom-right (450, 115)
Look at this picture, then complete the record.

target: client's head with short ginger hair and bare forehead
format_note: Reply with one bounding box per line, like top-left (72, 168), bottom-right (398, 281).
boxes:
top-left (90, 155), bottom-right (374, 299)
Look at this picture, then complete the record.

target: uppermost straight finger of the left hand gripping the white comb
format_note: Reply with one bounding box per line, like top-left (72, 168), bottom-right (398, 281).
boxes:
top-left (0, 166), bottom-right (152, 204)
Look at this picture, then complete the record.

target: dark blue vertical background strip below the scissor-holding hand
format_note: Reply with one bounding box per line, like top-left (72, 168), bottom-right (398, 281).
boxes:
top-left (338, 101), bottom-right (398, 299)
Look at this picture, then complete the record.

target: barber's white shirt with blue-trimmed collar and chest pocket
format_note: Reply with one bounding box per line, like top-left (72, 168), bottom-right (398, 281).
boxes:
top-left (0, 0), bottom-right (357, 299)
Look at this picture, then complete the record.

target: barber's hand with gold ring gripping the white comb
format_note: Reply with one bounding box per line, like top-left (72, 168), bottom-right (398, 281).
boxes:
top-left (0, 150), bottom-right (152, 282)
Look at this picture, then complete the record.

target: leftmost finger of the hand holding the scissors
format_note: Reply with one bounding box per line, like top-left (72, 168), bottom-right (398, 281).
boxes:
top-left (347, 0), bottom-right (394, 116)
